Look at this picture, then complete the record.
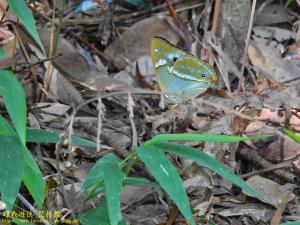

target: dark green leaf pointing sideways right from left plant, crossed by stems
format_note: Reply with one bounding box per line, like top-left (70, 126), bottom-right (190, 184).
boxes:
top-left (26, 128), bottom-right (97, 148)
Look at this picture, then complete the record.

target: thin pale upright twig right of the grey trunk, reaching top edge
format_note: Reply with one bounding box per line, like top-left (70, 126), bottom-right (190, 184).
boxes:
top-left (238, 0), bottom-right (256, 91)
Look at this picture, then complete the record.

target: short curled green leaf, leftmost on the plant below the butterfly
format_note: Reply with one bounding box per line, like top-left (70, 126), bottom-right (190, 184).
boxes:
top-left (80, 153), bottom-right (117, 194)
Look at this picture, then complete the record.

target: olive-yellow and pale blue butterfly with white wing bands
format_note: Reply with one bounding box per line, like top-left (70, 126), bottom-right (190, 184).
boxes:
top-left (151, 37), bottom-right (217, 105)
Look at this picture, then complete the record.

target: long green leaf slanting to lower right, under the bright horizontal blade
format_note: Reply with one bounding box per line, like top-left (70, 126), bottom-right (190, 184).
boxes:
top-left (155, 142), bottom-right (271, 204)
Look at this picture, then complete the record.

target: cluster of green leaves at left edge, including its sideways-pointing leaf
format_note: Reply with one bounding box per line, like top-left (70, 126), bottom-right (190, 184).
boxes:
top-left (0, 70), bottom-right (96, 210)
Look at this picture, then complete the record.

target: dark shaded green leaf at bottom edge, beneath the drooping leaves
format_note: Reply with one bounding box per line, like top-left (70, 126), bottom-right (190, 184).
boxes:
top-left (79, 198), bottom-right (128, 225)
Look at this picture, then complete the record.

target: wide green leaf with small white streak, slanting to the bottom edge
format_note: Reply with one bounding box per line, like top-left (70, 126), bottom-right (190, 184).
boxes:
top-left (134, 145), bottom-right (196, 225)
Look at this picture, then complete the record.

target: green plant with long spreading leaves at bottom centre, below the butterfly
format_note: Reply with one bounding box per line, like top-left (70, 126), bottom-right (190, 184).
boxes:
top-left (81, 134), bottom-right (270, 225)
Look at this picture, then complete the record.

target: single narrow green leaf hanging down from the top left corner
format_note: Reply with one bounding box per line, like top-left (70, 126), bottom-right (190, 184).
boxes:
top-left (6, 0), bottom-right (46, 55)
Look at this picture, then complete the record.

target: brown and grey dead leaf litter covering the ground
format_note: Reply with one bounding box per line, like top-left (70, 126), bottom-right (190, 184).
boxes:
top-left (0, 0), bottom-right (300, 224)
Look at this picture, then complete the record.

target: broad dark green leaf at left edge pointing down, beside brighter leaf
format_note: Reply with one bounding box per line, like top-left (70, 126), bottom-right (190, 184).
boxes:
top-left (0, 136), bottom-right (24, 210)
